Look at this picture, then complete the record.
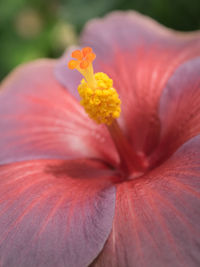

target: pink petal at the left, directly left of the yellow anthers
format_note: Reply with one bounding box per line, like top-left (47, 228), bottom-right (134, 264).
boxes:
top-left (0, 60), bottom-right (117, 166)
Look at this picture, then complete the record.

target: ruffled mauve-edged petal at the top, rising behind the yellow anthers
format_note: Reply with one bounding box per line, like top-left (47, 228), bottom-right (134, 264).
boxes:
top-left (57, 11), bottom-right (200, 154)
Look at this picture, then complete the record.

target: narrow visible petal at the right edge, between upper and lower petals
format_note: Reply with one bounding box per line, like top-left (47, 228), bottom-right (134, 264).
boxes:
top-left (152, 57), bottom-right (200, 168)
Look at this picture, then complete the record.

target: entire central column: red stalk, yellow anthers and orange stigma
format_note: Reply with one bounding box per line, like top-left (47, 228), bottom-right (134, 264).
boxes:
top-left (68, 47), bottom-right (148, 179)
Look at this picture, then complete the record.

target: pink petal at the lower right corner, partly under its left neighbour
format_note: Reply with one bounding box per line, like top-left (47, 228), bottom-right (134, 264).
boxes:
top-left (92, 136), bottom-right (200, 267)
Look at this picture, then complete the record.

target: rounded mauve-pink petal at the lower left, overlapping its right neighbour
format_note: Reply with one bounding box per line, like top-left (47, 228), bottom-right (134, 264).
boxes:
top-left (0, 160), bottom-right (115, 267)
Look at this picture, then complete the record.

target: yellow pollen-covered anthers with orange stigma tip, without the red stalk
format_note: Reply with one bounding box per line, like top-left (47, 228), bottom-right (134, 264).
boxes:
top-left (68, 47), bottom-right (121, 125)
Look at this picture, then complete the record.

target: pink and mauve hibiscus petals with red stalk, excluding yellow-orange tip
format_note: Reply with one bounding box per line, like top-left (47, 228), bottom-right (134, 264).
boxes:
top-left (0, 12), bottom-right (200, 267)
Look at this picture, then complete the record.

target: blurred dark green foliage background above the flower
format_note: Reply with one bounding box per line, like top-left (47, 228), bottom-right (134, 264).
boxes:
top-left (0, 0), bottom-right (200, 80)
